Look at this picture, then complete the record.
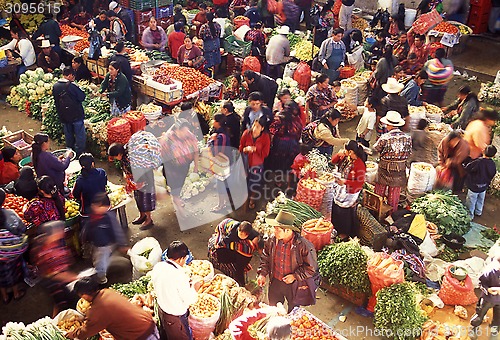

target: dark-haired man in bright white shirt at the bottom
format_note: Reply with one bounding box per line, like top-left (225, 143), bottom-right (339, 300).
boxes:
top-left (151, 241), bottom-right (201, 340)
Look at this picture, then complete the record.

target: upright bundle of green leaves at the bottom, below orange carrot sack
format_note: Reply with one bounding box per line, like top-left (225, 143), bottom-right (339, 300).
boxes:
top-left (374, 282), bottom-right (426, 340)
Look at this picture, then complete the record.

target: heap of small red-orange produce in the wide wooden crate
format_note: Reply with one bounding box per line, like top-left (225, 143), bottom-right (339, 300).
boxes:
top-left (155, 65), bottom-right (215, 96)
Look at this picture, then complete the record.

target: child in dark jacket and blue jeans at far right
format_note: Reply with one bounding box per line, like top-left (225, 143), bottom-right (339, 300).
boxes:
top-left (465, 145), bottom-right (497, 219)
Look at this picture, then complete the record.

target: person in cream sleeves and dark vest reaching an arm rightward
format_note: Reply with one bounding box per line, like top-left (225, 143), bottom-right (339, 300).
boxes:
top-left (314, 109), bottom-right (349, 157)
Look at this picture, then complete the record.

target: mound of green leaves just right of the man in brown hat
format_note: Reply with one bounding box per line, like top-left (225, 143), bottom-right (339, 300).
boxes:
top-left (318, 240), bottom-right (370, 293)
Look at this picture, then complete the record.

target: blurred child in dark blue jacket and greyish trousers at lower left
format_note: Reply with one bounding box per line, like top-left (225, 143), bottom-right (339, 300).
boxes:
top-left (84, 192), bottom-right (127, 284)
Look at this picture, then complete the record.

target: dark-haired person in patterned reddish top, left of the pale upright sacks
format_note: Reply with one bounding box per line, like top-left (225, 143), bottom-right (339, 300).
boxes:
top-left (306, 74), bottom-right (338, 122)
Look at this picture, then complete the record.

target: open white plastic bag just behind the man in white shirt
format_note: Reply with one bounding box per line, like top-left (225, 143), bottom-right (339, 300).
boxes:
top-left (127, 237), bottom-right (162, 280)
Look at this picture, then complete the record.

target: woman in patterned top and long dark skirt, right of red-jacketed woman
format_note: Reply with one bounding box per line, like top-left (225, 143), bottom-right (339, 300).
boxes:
top-left (268, 101), bottom-right (302, 186)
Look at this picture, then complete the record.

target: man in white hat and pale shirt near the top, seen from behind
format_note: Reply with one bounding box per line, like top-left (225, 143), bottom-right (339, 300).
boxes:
top-left (266, 26), bottom-right (290, 79)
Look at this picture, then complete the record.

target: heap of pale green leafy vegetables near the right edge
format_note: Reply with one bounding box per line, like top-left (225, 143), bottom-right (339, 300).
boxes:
top-left (411, 191), bottom-right (471, 235)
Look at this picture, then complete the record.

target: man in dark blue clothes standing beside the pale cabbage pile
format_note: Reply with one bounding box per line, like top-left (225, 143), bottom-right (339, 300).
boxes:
top-left (52, 66), bottom-right (87, 157)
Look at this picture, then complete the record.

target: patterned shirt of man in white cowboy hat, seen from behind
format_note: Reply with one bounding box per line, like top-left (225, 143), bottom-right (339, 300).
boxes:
top-left (373, 129), bottom-right (411, 161)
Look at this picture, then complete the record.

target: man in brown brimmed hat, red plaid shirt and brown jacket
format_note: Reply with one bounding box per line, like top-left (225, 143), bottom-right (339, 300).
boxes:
top-left (257, 210), bottom-right (318, 312)
